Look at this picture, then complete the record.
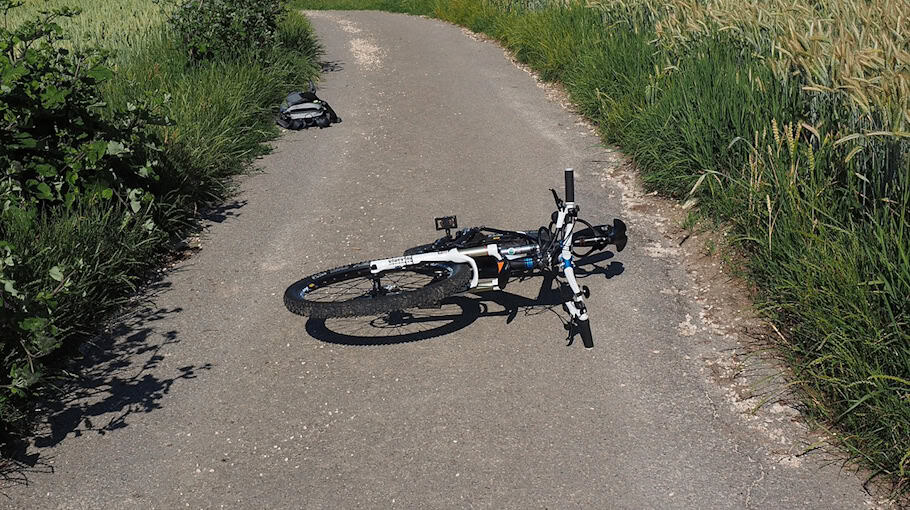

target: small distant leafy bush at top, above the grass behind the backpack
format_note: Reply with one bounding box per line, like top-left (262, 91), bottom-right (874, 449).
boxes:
top-left (168, 0), bottom-right (286, 60)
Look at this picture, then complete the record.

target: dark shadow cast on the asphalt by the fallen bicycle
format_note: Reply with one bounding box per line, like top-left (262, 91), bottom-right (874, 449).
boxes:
top-left (306, 253), bottom-right (624, 346)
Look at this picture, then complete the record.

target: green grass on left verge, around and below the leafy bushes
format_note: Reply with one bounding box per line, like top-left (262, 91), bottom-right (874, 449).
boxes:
top-left (0, 0), bottom-right (320, 434)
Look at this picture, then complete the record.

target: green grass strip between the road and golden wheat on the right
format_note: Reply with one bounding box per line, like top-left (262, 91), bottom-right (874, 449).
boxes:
top-left (295, 0), bottom-right (910, 492)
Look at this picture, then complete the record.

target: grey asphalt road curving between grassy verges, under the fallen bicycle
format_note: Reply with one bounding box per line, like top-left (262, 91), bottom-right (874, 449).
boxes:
top-left (0, 8), bottom-right (866, 509)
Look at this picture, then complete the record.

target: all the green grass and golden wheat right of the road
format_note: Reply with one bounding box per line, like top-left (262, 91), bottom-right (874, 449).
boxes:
top-left (296, 0), bottom-right (910, 491)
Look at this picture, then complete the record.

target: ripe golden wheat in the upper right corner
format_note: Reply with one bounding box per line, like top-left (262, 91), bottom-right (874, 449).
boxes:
top-left (594, 0), bottom-right (910, 227)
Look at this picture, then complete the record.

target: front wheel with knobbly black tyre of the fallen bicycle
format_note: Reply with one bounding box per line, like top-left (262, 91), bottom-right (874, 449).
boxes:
top-left (284, 262), bottom-right (472, 319)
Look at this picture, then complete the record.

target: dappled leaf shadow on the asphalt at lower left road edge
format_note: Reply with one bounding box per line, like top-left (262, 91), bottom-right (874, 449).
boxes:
top-left (0, 285), bottom-right (212, 493)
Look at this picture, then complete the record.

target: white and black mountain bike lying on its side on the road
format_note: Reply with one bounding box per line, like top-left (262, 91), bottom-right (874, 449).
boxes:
top-left (284, 168), bottom-right (627, 348)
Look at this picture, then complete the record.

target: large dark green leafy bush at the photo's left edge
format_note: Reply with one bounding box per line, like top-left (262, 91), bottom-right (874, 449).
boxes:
top-left (0, 0), bottom-right (160, 426)
